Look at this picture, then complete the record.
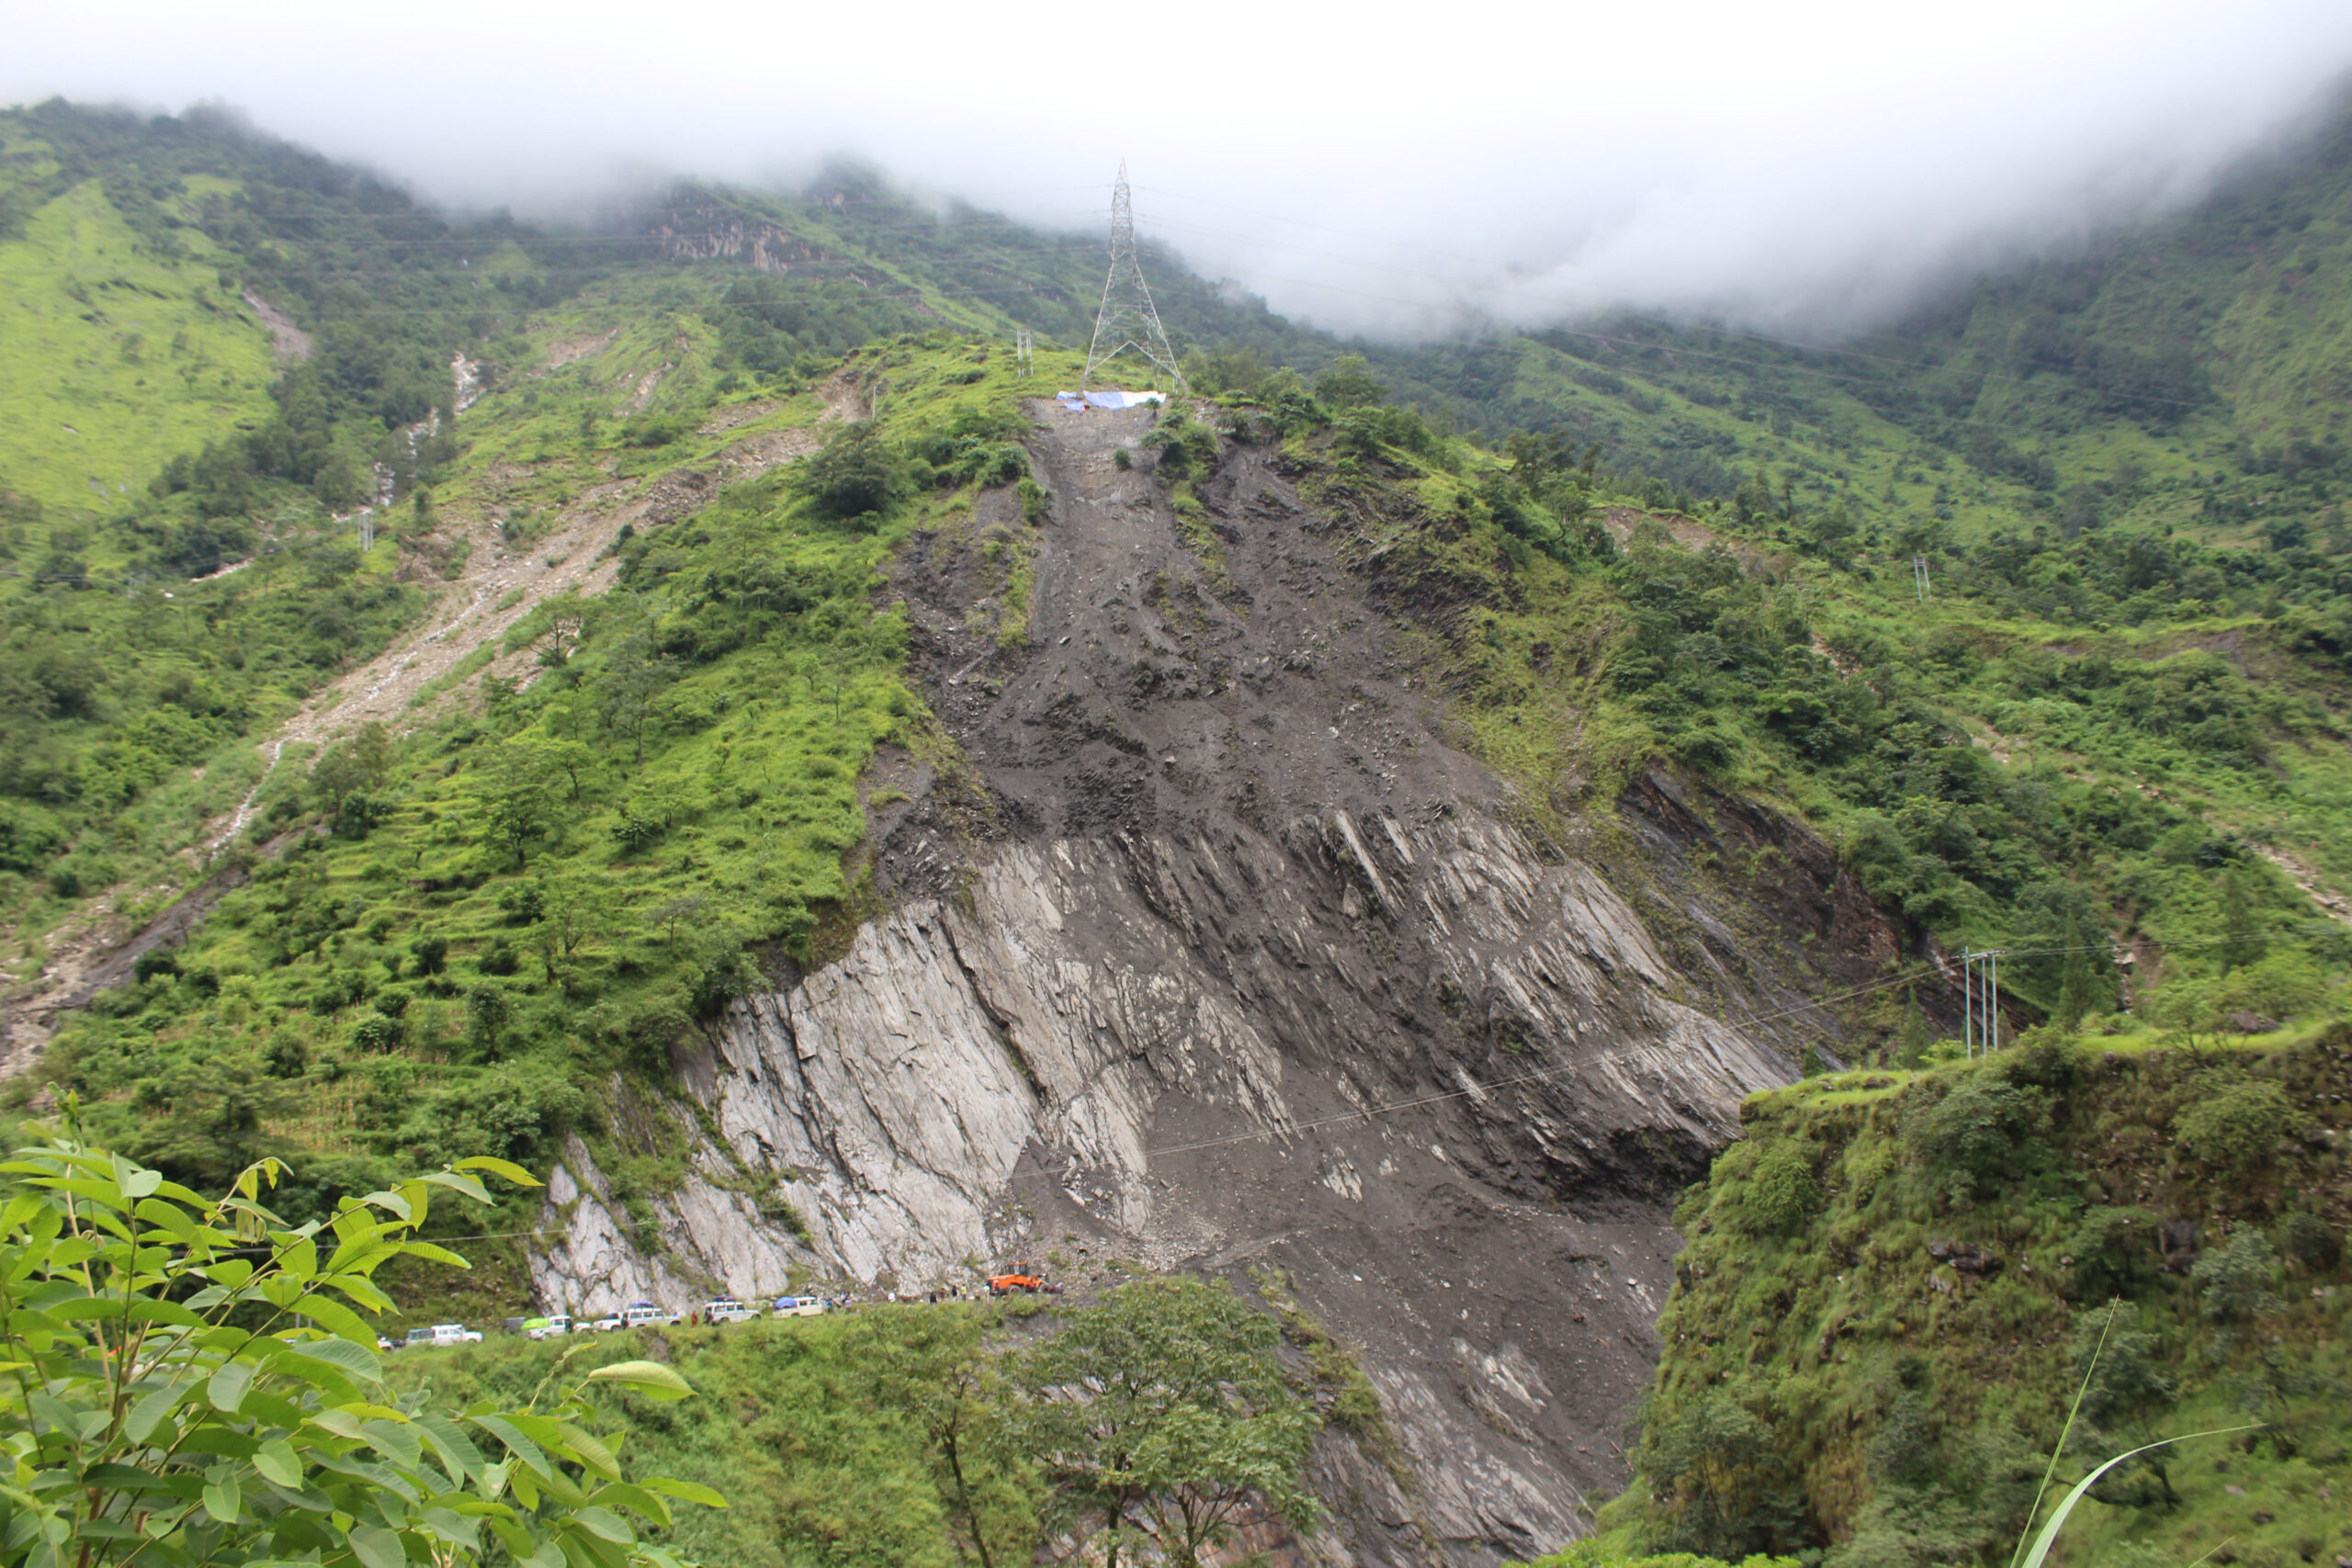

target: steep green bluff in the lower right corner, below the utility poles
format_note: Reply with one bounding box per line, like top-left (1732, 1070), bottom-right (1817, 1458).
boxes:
top-left (1601, 1027), bottom-right (2352, 1563)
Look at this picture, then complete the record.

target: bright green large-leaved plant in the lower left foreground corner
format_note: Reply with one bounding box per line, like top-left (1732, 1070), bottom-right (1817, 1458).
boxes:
top-left (0, 1135), bottom-right (724, 1568)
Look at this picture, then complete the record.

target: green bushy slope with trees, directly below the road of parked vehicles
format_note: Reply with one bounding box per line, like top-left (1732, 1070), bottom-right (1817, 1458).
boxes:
top-left (390, 1279), bottom-right (1362, 1568)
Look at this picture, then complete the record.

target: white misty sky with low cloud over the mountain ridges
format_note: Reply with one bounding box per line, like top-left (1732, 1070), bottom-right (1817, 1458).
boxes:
top-left (14, 0), bottom-right (2352, 332)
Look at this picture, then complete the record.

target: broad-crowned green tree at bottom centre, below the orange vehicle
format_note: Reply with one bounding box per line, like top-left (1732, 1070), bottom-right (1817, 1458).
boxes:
top-left (1023, 1279), bottom-right (1319, 1568)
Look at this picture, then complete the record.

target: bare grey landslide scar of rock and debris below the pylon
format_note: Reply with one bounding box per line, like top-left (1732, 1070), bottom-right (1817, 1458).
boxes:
top-left (537, 413), bottom-right (1884, 1563)
